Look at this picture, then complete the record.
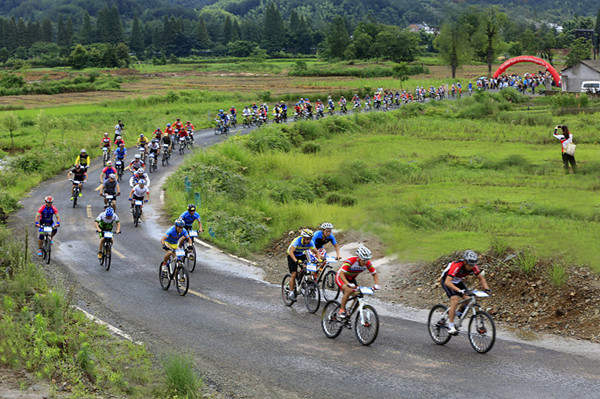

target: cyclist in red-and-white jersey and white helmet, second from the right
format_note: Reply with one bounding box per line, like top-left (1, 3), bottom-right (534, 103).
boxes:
top-left (335, 245), bottom-right (380, 319)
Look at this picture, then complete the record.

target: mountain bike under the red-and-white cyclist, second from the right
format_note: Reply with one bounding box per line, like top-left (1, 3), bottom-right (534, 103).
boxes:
top-left (321, 287), bottom-right (379, 345)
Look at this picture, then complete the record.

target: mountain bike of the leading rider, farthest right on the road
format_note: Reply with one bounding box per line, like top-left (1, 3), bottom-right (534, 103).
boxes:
top-left (427, 290), bottom-right (496, 353)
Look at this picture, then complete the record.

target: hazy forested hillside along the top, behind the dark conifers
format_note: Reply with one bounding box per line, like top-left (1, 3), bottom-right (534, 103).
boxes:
top-left (0, 0), bottom-right (599, 26)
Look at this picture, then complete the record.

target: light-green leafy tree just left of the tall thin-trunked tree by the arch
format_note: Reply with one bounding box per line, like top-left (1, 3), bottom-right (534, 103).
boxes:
top-left (433, 14), bottom-right (470, 79)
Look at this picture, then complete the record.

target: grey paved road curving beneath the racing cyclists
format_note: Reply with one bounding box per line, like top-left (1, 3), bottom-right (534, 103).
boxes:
top-left (11, 122), bottom-right (600, 398)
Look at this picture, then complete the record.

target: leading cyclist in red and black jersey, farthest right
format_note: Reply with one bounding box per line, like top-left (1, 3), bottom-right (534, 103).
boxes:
top-left (441, 250), bottom-right (491, 335)
